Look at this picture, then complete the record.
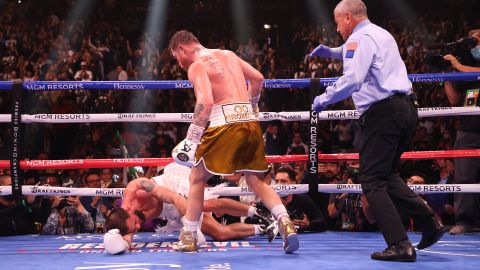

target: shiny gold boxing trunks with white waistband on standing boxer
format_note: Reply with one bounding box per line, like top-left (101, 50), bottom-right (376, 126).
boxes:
top-left (195, 103), bottom-right (268, 175)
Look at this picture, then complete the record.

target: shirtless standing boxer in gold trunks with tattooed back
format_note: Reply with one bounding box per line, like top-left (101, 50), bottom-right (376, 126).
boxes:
top-left (169, 31), bottom-right (299, 253)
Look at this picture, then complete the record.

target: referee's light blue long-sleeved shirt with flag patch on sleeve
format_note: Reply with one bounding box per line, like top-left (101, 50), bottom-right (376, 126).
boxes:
top-left (319, 19), bottom-right (412, 114)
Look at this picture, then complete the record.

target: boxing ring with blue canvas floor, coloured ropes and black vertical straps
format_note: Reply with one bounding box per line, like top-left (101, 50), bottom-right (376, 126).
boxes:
top-left (0, 73), bottom-right (480, 269)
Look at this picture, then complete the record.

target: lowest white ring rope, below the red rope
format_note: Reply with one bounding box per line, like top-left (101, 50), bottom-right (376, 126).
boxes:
top-left (0, 184), bottom-right (480, 197)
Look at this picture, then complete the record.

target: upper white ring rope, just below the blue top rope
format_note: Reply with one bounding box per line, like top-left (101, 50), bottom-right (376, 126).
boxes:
top-left (0, 107), bottom-right (480, 123)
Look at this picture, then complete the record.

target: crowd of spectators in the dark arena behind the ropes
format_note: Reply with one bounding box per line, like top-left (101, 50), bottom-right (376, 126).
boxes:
top-left (0, 0), bottom-right (478, 234)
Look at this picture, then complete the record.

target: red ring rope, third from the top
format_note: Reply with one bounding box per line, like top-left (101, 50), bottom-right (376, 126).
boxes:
top-left (0, 149), bottom-right (480, 170)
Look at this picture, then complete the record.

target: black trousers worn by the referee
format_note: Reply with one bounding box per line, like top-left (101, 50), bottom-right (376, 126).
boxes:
top-left (359, 95), bottom-right (433, 246)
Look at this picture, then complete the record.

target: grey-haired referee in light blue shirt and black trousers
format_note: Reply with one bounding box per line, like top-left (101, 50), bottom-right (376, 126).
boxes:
top-left (310, 0), bottom-right (445, 262)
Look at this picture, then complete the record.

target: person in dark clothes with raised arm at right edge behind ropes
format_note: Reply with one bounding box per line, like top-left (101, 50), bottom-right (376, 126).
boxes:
top-left (443, 29), bottom-right (480, 234)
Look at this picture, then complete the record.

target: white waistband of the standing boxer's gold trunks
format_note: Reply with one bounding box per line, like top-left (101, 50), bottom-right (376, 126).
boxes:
top-left (209, 102), bottom-right (257, 127)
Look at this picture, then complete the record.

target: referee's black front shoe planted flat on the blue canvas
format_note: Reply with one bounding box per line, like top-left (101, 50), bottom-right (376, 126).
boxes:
top-left (370, 239), bottom-right (417, 262)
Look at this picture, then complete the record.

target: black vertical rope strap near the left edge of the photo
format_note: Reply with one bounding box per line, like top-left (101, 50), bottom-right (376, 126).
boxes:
top-left (10, 80), bottom-right (24, 196)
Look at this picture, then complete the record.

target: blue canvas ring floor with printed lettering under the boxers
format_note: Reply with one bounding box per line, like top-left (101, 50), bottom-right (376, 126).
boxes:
top-left (0, 232), bottom-right (480, 270)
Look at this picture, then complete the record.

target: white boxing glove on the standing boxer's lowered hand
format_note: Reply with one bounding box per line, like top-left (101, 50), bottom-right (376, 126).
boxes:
top-left (172, 124), bottom-right (205, 167)
